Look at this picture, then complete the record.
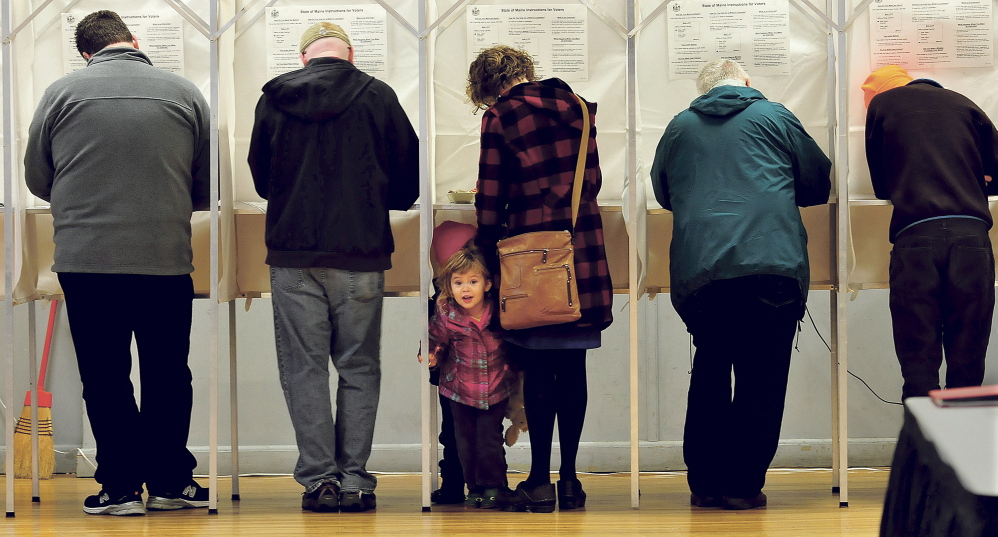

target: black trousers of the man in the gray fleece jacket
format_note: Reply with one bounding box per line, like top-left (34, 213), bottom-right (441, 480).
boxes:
top-left (59, 272), bottom-right (197, 496)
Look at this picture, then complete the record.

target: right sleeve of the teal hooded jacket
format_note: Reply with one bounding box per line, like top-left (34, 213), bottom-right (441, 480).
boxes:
top-left (774, 103), bottom-right (832, 207)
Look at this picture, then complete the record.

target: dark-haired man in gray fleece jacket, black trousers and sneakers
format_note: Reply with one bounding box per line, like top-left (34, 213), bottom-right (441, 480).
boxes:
top-left (24, 11), bottom-right (209, 515)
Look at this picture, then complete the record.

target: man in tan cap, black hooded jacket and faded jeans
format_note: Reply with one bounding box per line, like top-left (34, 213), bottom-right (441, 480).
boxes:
top-left (249, 22), bottom-right (419, 511)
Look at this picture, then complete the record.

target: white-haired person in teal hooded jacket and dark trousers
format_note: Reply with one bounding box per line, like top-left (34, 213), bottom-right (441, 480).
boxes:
top-left (651, 60), bottom-right (831, 509)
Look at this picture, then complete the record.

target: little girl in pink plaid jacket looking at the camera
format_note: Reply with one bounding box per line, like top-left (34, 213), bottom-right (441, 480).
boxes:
top-left (429, 238), bottom-right (516, 509)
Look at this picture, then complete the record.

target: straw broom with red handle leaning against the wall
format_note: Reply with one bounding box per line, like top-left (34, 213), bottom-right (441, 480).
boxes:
top-left (14, 300), bottom-right (59, 479)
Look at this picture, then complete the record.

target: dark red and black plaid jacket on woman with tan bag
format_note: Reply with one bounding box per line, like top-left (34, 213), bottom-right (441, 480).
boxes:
top-left (475, 78), bottom-right (613, 329)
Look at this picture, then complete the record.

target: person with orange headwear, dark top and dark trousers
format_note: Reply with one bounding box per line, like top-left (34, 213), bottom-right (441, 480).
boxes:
top-left (863, 65), bottom-right (998, 397)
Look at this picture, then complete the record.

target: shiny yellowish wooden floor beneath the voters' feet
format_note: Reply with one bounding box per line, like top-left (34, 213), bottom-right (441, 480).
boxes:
top-left (0, 470), bottom-right (888, 537)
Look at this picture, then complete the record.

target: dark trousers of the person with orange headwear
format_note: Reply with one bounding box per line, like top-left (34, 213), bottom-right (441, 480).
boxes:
top-left (890, 218), bottom-right (995, 398)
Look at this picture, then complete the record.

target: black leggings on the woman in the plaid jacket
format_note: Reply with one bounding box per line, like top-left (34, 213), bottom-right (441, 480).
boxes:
top-left (507, 345), bottom-right (589, 486)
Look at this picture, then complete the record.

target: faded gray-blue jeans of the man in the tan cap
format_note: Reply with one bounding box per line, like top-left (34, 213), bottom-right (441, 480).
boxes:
top-left (270, 267), bottom-right (385, 492)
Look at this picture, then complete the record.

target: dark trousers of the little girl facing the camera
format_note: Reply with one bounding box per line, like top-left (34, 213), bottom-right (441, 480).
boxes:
top-left (450, 399), bottom-right (509, 490)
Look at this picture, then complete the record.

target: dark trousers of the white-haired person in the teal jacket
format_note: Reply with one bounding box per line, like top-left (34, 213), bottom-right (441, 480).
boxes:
top-left (683, 275), bottom-right (803, 498)
